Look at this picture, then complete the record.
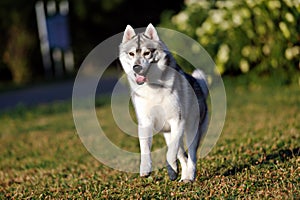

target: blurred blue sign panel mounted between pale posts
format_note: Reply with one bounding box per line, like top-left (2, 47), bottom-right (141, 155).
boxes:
top-left (46, 14), bottom-right (71, 50)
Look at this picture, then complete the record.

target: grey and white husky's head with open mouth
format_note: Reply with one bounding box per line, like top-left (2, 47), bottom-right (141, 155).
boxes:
top-left (119, 24), bottom-right (171, 85)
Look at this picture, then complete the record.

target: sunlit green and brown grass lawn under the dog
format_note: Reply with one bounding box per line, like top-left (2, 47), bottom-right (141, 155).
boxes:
top-left (0, 78), bottom-right (300, 199)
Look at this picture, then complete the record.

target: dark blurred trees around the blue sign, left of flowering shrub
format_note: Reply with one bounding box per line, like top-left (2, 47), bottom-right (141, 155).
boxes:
top-left (0, 0), bottom-right (183, 83)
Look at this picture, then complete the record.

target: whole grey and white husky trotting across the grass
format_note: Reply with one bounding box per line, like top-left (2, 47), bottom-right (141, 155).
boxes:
top-left (119, 24), bottom-right (208, 182)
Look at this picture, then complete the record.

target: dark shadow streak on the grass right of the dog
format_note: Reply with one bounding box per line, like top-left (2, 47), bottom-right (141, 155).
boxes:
top-left (216, 147), bottom-right (300, 176)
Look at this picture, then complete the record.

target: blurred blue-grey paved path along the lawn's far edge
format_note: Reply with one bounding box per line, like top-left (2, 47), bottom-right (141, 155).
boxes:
top-left (0, 78), bottom-right (117, 111)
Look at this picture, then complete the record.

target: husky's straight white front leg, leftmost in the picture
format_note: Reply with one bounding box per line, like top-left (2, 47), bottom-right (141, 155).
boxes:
top-left (138, 126), bottom-right (152, 177)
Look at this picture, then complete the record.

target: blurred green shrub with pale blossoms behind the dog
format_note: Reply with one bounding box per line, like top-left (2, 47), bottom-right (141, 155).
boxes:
top-left (161, 0), bottom-right (300, 77)
